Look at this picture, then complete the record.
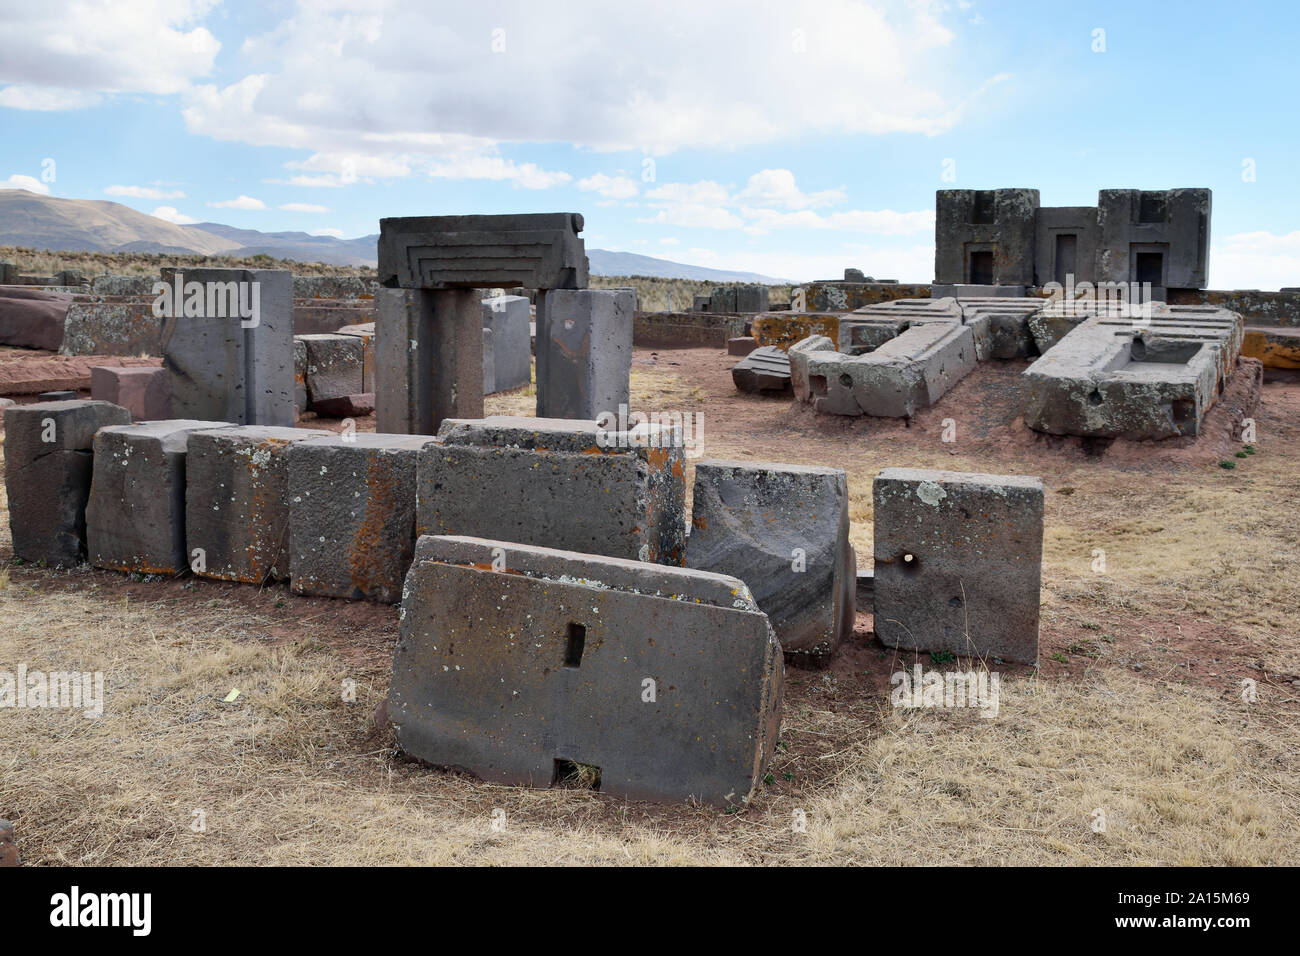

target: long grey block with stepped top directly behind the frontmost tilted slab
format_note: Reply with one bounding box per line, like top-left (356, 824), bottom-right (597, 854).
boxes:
top-left (417, 416), bottom-right (685, 564)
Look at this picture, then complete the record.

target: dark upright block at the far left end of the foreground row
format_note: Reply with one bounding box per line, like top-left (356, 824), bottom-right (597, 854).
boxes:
top-left (4, 401), bottom-right (131, 566)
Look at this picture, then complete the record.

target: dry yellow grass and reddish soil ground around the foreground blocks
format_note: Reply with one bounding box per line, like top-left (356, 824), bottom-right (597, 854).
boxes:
top-left (0, 350), bottom-right (1300, 865)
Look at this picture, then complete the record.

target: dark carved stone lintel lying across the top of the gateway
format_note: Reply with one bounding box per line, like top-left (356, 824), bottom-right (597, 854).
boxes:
top-left (378, 212), bottom-right (588, 290)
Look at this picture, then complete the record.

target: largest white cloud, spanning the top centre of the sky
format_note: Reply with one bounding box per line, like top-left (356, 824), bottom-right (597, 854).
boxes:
top-left (170, 0), bottom-right (984, 187)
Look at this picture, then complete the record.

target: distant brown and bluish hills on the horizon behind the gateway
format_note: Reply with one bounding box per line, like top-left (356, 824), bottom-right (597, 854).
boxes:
top-left (0, 189), bottom-right (787, 285)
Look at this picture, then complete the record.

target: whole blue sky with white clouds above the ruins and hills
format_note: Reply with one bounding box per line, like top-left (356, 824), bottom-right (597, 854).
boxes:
top-left (0, 0), bottom-right (1300, 289)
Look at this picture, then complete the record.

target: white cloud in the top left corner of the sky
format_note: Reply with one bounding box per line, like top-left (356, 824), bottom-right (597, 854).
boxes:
top-left (0, 0), bottom-right (221, 111)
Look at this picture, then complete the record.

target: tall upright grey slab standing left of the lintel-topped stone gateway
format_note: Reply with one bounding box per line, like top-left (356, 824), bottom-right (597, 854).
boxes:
top-left (163, 268), bottom-right (294, 425)
